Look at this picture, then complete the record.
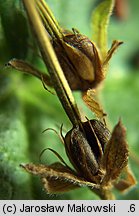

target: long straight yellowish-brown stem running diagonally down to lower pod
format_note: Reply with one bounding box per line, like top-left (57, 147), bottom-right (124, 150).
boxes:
top-left (22, 0), bottom-right (81, 126)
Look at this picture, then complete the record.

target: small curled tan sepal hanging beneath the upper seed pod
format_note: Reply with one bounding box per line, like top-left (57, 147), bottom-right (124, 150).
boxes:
top-left (83, 89), bottom-right (107, 119)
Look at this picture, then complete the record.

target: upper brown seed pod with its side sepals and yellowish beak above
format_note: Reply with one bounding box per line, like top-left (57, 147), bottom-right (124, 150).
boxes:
top-left (9, 0), bottom-right (122, 92)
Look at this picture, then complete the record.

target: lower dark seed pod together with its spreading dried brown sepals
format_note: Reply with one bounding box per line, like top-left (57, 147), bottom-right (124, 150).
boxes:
top-left (21, 120), bottom-right (136, 199)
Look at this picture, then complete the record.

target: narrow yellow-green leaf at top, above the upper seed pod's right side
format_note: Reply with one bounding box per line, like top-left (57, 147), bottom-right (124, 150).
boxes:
top-left (92, 0), bottom-right (114, 60)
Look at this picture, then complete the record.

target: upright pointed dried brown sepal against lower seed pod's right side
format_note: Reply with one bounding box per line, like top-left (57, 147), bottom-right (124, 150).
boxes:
top-left (102, 121), bottom-right (128, 184)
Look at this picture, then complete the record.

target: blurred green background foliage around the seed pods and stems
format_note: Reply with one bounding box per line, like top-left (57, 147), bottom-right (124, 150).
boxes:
top-left (0, 0), bottom-right (139, 199)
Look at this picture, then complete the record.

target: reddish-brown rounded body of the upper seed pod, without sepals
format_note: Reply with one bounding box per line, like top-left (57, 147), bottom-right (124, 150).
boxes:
top-left (53, 30), bottom-right (104, 91)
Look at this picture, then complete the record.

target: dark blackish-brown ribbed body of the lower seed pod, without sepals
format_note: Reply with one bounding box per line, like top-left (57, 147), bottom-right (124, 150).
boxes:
top-left (65, 120), bottom-right (110, 182)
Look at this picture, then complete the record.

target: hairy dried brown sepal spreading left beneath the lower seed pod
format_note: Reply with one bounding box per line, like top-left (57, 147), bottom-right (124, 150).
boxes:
top-left (21, 163), bottom-right (99, 193)
